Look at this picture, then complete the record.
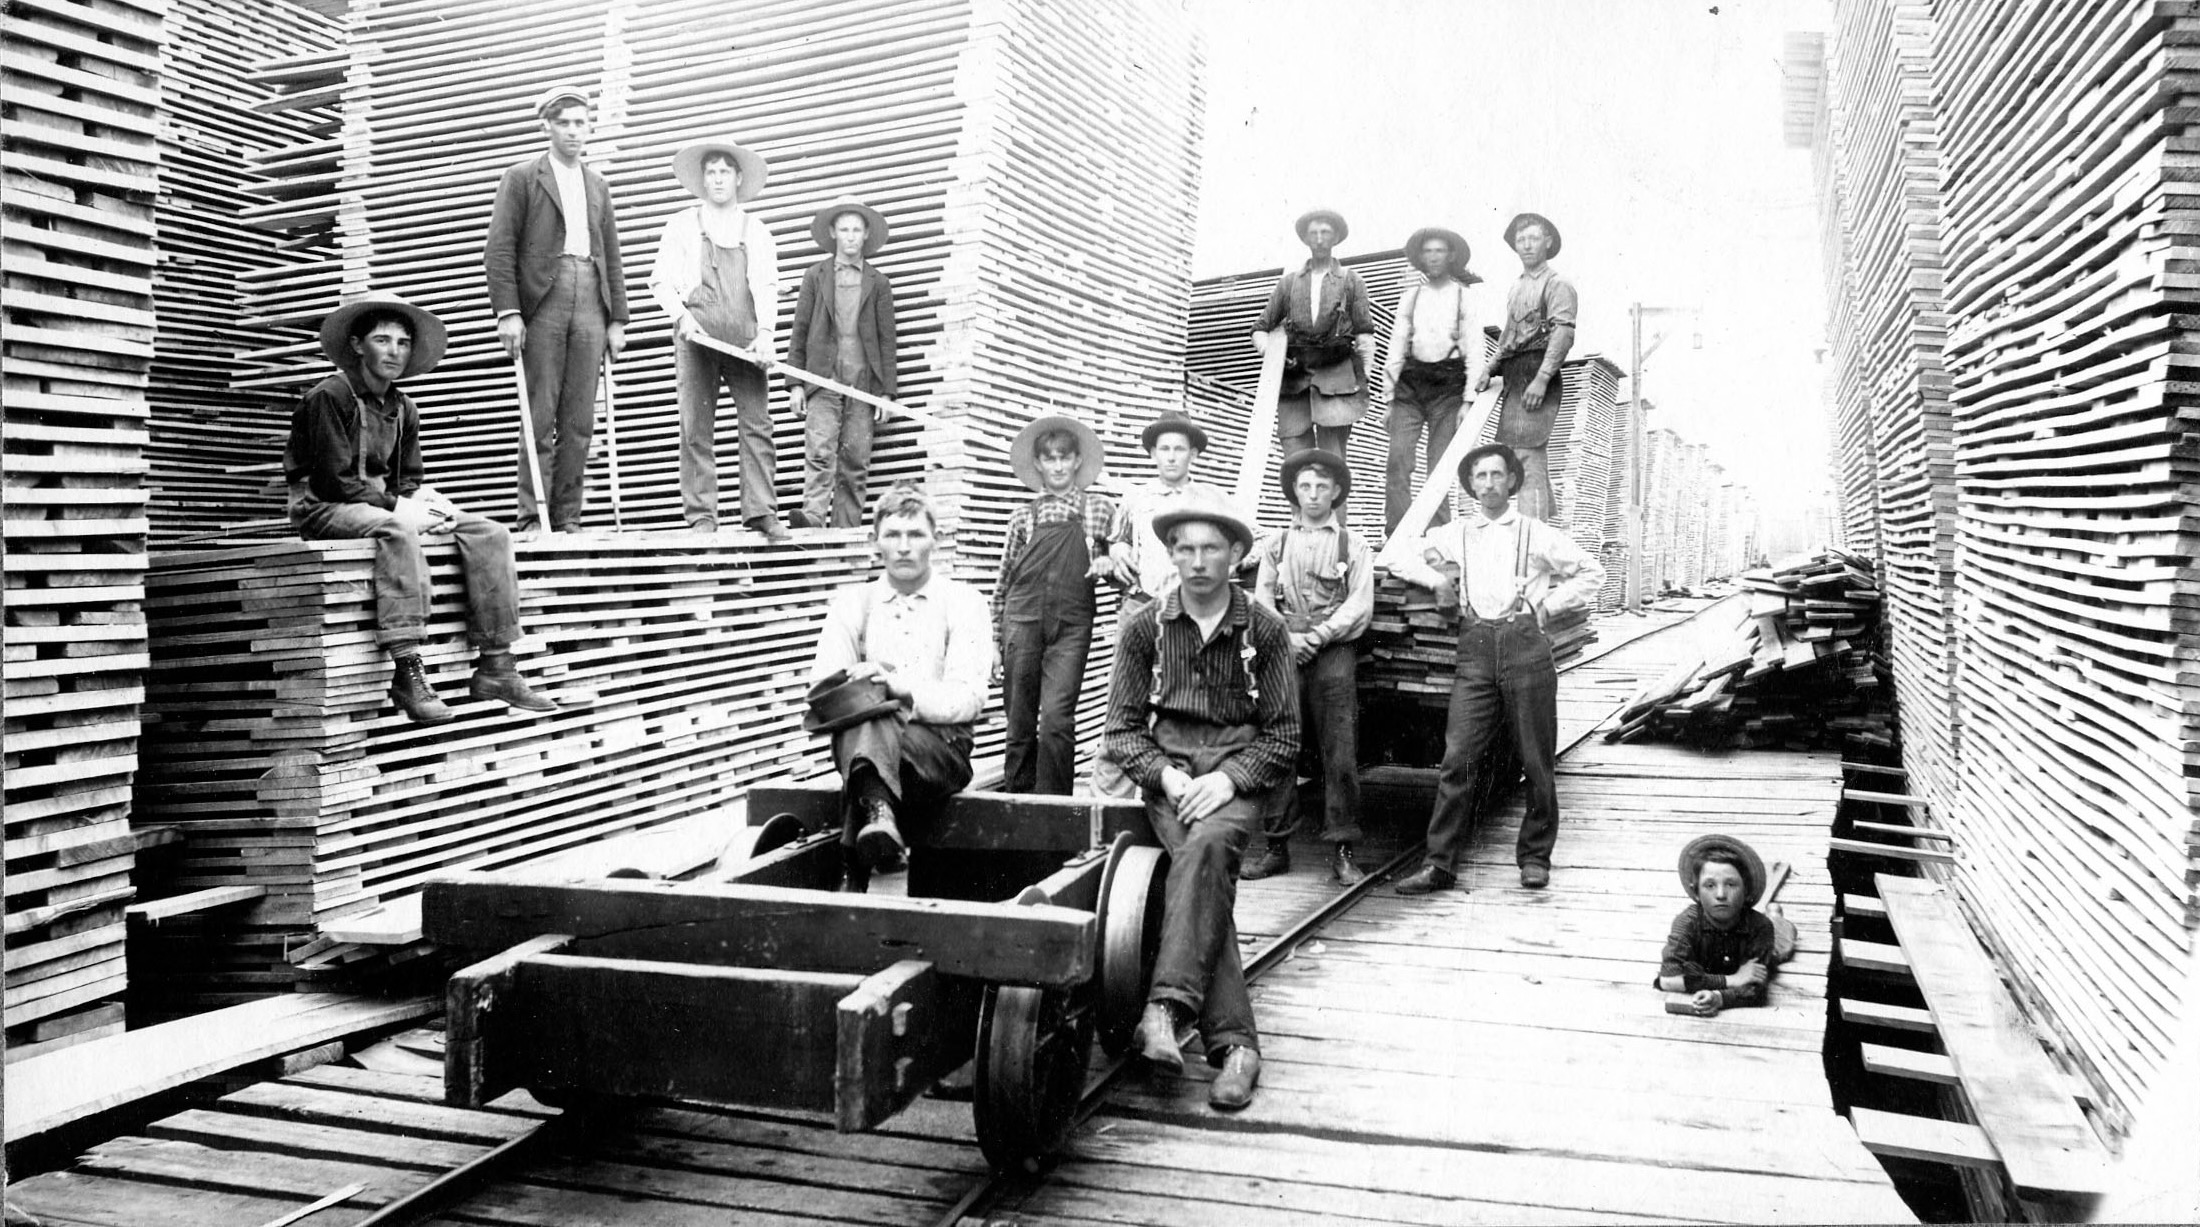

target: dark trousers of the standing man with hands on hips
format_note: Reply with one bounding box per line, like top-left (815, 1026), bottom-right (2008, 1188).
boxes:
top-left (1428, 614), bottom-right (1558, 873)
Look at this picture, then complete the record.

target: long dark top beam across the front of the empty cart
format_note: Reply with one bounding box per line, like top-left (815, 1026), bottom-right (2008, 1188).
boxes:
top-left (422, 873), bottom-right (1096, 987)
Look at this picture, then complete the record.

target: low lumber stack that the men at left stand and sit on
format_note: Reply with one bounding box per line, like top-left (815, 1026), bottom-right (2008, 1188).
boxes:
top-left (139, 532), bottom-right (869, 1005)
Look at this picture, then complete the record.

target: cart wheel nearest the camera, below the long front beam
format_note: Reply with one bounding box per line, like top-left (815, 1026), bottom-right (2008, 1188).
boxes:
top-left (970, 985), bottom-right (1093, 1172)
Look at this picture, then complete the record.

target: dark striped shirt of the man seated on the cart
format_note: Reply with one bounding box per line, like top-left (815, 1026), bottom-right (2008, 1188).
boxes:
top-left (1107, 585), bottom-right (1298, 796)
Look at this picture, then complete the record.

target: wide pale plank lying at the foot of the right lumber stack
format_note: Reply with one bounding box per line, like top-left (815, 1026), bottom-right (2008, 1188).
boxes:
top-left (1879, 873), bottom-right (2110, 1198)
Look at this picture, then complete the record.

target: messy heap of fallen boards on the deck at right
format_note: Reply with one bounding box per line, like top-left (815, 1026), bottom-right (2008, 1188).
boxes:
top-left (1604, 550), bottom-right (1892, 750)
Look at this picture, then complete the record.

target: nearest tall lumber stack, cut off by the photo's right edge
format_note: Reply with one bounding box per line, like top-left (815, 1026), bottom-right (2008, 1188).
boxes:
top-left (1932, 0), bottom-right (2200, 1119)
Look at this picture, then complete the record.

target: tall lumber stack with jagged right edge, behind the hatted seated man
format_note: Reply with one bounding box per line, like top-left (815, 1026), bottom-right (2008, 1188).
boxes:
top-left (145, 0), bottom-right (337, 548)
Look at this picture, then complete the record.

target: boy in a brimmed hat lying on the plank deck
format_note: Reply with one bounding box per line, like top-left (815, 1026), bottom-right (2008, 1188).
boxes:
top-left (1657, 836), bottom-right (1795, 1018)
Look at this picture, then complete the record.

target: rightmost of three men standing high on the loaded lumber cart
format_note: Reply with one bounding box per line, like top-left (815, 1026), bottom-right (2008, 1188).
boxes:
top-left (1474, 213), bottom-right (1580, 519)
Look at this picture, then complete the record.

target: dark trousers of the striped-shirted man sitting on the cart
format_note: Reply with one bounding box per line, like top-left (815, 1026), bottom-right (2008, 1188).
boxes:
top-left (1146, 717), bottom-right (1267, 1064)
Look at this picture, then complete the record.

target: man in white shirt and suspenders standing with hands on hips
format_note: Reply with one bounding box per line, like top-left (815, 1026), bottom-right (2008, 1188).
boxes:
top-left (1390, 444), bottom-right (1604, 895)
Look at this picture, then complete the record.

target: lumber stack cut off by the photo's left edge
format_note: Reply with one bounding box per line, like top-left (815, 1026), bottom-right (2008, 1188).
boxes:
top-left (0, 4), bottom-right (163, 1058)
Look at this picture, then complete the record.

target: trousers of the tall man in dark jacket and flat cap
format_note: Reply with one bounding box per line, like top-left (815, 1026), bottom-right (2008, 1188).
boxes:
top-left (517, 257), bottom-right (609, 532)
